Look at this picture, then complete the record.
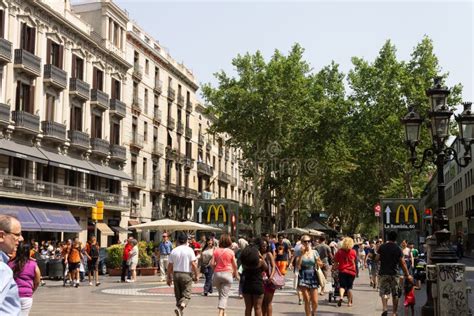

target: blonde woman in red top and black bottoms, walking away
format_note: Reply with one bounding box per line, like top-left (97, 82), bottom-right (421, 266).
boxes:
top-left (332, 237), bottom-right (357, 306)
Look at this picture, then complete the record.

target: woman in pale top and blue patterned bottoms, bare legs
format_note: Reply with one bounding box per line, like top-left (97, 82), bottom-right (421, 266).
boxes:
top-left (296, 235), bottom-right (323, 316)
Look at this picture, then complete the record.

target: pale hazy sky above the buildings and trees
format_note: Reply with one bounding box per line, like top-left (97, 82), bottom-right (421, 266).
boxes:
top-left (115, 0), bottom-right (474, 101)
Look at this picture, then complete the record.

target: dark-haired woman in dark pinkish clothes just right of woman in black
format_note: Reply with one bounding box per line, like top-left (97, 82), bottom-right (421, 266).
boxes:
top-left (255, 238), bottom-right (276, 316)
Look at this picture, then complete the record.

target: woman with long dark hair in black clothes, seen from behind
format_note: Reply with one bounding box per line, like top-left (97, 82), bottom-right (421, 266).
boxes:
top-left (240, 246), bottom-right (268, 316)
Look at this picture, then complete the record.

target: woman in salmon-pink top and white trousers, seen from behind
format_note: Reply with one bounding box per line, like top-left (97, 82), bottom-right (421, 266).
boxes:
top-left (211, 234), bottom-right (237, 316)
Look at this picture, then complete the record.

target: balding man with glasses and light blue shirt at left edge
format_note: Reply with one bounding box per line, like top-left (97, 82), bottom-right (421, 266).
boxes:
top-left (0, 215), bottom-right (23, 316)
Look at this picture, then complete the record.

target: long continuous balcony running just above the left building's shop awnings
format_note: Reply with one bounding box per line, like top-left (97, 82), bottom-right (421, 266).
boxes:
top-left (0, 174), bottom-right (130, 210)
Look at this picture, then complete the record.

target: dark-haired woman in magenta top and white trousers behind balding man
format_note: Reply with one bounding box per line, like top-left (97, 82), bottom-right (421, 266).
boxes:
top-left (8, 243), bottom-right (41, 316)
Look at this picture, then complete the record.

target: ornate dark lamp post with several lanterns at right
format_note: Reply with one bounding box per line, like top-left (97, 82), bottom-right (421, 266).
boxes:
top-left (401, 78), bottom-right (474, 316)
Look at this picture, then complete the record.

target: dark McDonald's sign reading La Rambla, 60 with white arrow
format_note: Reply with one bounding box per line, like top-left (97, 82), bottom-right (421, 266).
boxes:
top-left (381, 199), bottom-right (421, 229)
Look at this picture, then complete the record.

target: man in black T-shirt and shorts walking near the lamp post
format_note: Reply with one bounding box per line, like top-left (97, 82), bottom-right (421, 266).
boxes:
top-left (375, 230), bottom-right (413, 316)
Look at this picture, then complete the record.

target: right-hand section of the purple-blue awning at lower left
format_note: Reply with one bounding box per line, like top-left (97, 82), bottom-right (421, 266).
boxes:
top-left (28, 204), bottom-right (82, 233)
